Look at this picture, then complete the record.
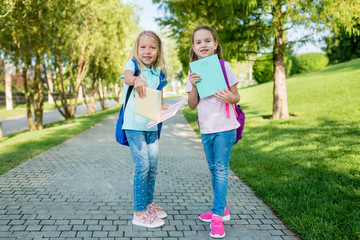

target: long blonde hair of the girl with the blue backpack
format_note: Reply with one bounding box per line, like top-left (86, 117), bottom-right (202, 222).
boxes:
top-left (130, 31), bottom-right (167, 79)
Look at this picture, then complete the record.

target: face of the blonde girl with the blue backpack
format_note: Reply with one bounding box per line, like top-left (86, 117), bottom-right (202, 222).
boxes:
top-left (137, 35), bottom-right (158, 68)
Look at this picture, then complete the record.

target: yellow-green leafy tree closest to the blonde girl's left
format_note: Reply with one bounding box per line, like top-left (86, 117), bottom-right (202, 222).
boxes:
top-left (84, 1), bottom-right (140, 113)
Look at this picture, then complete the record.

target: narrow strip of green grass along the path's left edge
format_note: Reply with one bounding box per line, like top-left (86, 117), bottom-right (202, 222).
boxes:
top-left (0, 107), bottom-right (120, 174)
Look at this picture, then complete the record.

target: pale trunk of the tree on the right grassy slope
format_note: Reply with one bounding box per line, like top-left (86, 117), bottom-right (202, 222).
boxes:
top-left (272, 4), bottom-right (289, 120)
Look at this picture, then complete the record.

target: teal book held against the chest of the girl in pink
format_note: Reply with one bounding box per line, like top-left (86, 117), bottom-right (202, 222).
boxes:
top-left (190, 54), bottom-right (227, 98)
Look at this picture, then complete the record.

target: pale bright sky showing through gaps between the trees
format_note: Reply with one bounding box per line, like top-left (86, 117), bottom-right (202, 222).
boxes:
top-left (124, 0), bottom-right (323, 54)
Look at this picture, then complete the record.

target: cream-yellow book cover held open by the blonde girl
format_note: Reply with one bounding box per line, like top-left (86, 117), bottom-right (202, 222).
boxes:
top-left (135, 88), bottom-right (161, 122)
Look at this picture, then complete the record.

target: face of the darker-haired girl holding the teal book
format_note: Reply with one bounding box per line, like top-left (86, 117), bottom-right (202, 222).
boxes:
top-left (192, 29), bottom-right (218, 58)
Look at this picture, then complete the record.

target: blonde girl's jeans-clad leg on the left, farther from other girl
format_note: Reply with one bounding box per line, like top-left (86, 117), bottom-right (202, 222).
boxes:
top-left (125, 130), bottom-right (149, 212)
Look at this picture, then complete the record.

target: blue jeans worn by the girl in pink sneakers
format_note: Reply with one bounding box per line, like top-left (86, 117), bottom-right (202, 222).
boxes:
top-left (201, 129), bottom-right (236, 216)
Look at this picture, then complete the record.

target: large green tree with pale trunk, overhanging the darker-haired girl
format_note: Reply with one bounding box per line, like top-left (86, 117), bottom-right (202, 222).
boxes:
top-left (153, 0), bottom-right (360, 119)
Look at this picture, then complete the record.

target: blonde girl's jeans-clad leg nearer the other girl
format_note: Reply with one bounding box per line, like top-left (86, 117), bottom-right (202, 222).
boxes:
top-left (146, 132), bottom-right (159, 205)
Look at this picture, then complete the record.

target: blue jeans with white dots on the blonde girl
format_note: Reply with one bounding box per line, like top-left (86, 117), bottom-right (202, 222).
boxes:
top-left (125, 130), bottom-right (159, 212)
